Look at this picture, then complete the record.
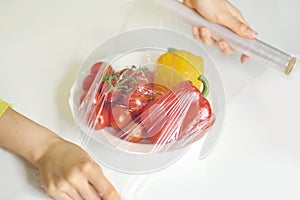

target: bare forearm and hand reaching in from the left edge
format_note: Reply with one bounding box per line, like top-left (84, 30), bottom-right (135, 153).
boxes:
top-left (0, 108), bottom-right (120, 200)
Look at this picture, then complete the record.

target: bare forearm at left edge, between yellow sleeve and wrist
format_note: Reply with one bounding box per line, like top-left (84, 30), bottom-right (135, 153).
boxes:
top-left (0, 108), bottom-right (61, 166)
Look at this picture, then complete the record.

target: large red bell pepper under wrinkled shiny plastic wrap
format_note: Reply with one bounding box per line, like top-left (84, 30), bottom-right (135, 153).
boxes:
top-left (140, 78), bottom-right (214, 144)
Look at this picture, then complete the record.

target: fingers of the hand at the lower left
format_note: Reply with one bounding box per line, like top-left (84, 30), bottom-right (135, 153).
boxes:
top-left (44, 161), bottom-right (121, 200)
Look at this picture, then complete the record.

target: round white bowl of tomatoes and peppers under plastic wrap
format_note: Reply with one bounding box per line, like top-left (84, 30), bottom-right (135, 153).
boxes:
top-left (70, 28), bottom-right (224, 174)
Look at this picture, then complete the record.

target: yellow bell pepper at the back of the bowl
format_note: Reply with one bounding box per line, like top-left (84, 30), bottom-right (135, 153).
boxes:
top-left (155, 48), bottom-right (204, 94)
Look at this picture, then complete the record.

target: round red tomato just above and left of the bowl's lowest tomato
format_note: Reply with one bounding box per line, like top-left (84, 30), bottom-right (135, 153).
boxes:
top-left (110, 105), bottom-right (132, 129)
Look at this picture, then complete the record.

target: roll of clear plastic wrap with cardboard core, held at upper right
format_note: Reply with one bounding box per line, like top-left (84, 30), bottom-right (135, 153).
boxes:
top-left (155, 0), bottom-right (296, 75)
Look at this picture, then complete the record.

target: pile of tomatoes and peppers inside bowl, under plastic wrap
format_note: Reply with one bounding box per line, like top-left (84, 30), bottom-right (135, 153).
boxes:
top-left (79, 50), bottom-right (214, 146)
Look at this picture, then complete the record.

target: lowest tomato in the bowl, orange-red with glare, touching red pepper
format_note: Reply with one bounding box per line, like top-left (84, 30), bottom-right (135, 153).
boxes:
top-left (122, 122), bottom-right (146, 143)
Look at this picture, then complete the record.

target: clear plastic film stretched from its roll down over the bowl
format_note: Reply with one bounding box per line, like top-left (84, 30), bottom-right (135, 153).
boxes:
top-left (69, 0), bottom-right (296, 199)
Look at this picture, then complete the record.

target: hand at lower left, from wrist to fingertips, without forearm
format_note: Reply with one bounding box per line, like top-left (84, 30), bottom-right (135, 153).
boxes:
top-left (36, 138), bottom-right (120, 200)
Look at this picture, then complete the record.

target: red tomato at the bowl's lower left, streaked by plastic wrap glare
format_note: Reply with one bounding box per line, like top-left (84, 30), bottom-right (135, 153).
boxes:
top-left (88, 106), bottom-right (109, 130)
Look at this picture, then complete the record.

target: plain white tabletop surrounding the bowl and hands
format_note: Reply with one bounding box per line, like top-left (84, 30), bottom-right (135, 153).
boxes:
top-left (0, 0), bottom-right (300, 200)
